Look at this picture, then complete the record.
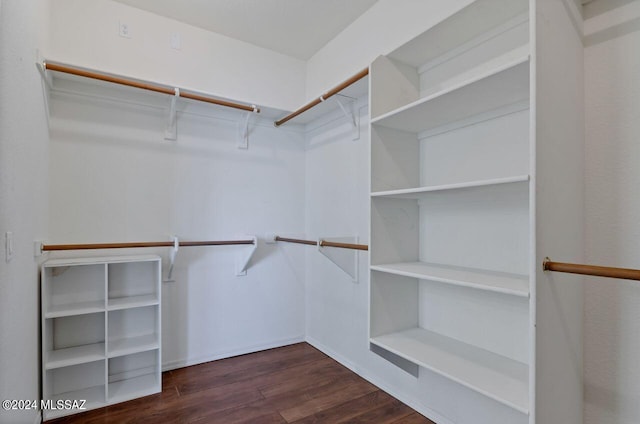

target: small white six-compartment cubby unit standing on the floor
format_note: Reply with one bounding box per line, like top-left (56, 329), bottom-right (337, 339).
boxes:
top-left (41, 255), bottom-right (161, 419)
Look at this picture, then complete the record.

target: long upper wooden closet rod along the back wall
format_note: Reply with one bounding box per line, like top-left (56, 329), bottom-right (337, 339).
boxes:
top-left (43, 62), bottom-right (260, 113)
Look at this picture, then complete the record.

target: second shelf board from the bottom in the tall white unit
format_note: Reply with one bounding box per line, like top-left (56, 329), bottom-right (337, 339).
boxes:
top-left (371, 262), bottom-right (529, 297)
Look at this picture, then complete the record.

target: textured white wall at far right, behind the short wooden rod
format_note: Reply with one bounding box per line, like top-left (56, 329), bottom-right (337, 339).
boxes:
top-left (584, 1), bottom-right (640, 424)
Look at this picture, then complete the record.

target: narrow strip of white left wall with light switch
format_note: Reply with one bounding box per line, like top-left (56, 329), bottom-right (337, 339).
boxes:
top-left (0, 0), bottom-right (48, 424)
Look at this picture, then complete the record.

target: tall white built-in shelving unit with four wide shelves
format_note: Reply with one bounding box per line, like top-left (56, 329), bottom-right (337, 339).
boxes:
top-left (369, 0), bottom-right (583, 424)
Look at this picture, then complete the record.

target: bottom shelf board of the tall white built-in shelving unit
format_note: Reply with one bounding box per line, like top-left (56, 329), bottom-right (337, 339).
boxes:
top-left (370, 328), bottom-right (529, 414)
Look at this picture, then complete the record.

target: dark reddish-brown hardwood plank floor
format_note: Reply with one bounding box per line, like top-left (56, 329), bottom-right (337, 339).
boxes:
top-left (47, 343), bottom-right (434, 424)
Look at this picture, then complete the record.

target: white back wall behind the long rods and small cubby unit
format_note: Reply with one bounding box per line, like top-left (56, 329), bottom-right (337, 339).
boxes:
top-left (47, 0), bottom-right (306, 374)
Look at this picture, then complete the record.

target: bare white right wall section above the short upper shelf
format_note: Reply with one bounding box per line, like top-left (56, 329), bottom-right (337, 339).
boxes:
top-left (306, 0), bottom-right (472, 99)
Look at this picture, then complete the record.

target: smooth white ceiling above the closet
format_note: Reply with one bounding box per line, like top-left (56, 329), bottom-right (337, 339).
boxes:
top-left (115, 0), bottom-right (377, 60)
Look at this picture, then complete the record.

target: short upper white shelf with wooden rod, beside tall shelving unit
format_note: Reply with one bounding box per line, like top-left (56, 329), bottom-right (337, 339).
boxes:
top-left (274, 68), bottom-right (369, 127)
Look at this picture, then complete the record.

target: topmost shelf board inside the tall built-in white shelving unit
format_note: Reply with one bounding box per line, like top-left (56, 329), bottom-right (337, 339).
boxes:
top-left (371, 55), bottom-right (529, 134)
